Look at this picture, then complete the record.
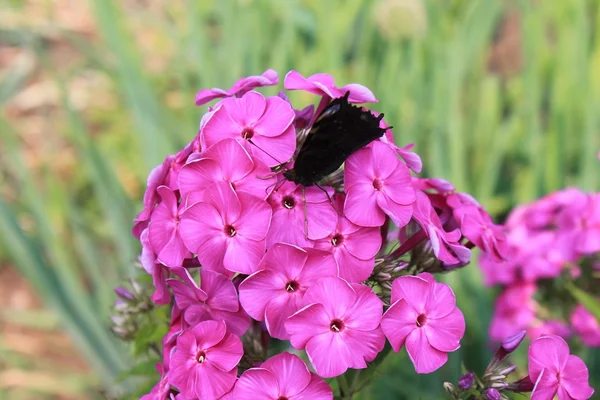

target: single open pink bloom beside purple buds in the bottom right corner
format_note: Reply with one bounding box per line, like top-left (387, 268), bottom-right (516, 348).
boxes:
top-left (529, 335), bottom-right (594, 400)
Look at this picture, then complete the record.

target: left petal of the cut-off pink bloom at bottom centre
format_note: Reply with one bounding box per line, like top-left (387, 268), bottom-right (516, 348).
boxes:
top-left (233, 368), bottom-right (279, 400)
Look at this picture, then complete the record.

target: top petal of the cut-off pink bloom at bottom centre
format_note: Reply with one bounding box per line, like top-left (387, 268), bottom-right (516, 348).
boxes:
top-left (261, 353), bottom-right (311, 398)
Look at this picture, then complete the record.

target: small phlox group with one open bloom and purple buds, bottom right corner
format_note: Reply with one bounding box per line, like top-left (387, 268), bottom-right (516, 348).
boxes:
top-left (444, 331), bottom-right (594, 400)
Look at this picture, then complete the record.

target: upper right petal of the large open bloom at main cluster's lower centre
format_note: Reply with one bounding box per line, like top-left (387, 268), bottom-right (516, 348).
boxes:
top-left (344, 284), bottom-right (383, 331)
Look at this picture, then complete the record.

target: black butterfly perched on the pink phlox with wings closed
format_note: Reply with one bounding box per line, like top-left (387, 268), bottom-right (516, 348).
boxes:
top-left (283, 92), bottom-right (389, 186)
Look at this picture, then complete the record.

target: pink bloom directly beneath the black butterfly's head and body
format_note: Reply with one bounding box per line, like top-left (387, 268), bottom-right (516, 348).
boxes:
top-left (267, 181), bottom-right (337, 247)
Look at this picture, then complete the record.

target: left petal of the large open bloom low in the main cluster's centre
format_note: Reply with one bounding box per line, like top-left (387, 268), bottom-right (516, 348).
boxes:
top-left (284, 304), bottom-right (331, 349)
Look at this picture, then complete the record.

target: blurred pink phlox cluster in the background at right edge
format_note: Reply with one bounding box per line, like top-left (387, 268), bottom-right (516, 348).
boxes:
top-left (480, 188), bottom-right (600, 347)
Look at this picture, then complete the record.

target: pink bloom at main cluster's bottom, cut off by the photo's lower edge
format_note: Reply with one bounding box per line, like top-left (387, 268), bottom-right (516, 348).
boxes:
top-left (233, 353), bottom-right (333, 400)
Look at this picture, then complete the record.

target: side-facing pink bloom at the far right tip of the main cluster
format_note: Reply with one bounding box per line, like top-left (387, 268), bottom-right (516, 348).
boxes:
top-left (447, 193), bottom-right (509, 262)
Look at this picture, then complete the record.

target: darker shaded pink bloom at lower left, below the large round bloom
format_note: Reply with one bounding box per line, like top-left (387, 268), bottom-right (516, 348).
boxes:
top-left (167, 268), bottom-right (250, 336)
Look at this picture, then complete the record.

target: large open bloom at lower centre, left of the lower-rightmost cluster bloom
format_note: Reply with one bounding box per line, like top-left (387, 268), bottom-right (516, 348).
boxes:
top-left (285, 278), bottom-right (385, 378)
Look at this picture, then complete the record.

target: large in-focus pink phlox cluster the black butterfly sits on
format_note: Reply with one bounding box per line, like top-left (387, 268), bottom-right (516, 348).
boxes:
top-left (133, 70), bottom-right (506, 400)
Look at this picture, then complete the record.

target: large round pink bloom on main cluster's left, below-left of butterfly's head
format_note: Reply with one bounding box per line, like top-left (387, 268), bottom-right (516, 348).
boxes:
top-left (179, 182), bottom-right (271, 274)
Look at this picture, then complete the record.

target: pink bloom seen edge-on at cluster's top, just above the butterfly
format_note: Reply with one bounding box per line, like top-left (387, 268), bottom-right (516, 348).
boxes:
top-left (283, 70), bottom-right (378, 103)
